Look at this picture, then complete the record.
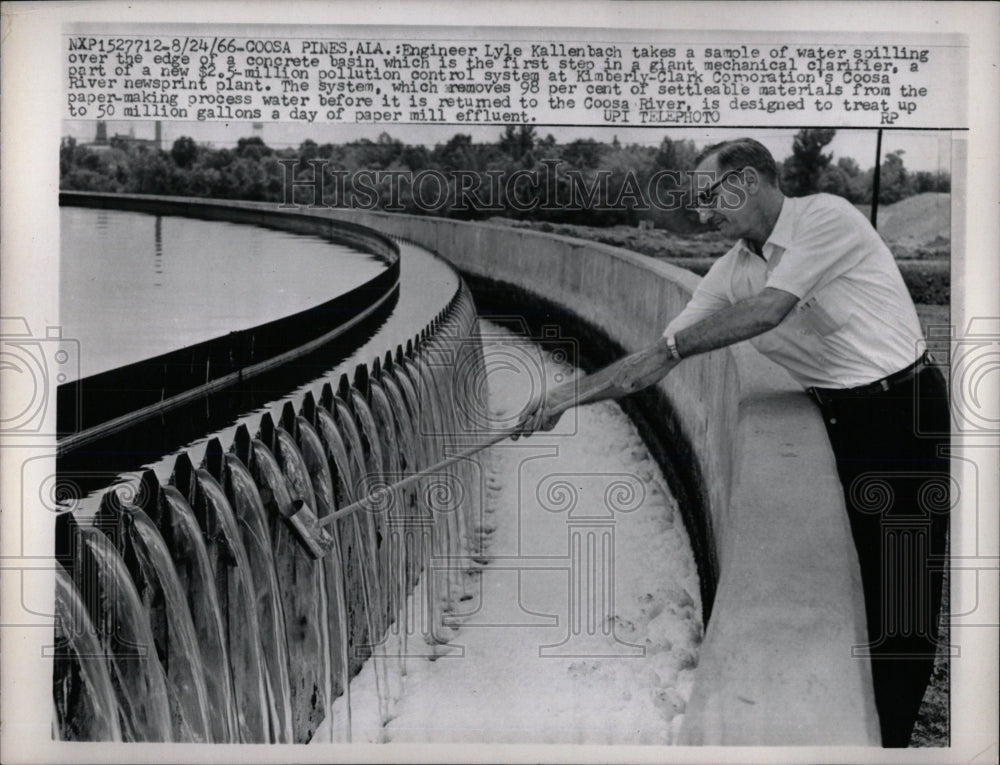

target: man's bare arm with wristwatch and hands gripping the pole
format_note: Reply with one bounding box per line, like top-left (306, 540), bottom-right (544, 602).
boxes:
top-left (520, 287), bottom-right (798, 434)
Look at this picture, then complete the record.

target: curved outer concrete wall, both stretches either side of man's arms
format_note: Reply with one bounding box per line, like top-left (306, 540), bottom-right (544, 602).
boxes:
top-left (330, 210), bottom-right (879, 745)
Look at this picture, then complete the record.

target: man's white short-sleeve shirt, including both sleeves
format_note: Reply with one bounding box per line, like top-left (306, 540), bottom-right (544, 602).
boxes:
top-left (664, 194), bottom-right (924, 388)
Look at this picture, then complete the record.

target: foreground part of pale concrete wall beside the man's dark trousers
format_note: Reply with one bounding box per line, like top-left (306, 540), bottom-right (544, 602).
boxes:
top-left (678, 346), bottom-right (881, 746)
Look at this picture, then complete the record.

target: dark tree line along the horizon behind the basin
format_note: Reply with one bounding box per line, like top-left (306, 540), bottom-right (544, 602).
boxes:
top-left (59, 126), bottom-right (950, 232)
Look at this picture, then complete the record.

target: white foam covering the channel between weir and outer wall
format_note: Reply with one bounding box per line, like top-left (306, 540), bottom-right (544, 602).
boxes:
top-left (317, 325), bottom-right (702, 744)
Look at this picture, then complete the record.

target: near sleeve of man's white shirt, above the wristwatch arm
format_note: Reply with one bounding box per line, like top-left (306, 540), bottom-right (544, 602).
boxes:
top-left (764, 198), bottom-right (870, 300)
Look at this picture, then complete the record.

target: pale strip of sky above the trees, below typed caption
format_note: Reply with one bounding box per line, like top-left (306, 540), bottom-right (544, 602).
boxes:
top-left (62, 120), bottom-right (952, 171)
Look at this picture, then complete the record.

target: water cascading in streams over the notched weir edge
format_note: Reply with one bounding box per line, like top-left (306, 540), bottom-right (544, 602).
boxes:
top-left (54, 287), bottom-right (478, 743)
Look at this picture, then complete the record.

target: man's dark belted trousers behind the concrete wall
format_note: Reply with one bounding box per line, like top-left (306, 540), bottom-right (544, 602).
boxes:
top-left (810, 366), bottom-right (951, 747)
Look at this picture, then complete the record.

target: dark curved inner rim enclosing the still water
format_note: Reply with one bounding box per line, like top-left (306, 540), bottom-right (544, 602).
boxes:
top-left (57, 191), bottom-right (400, 448)
